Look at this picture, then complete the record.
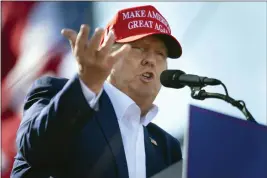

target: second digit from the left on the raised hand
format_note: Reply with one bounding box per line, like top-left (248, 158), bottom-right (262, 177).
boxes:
top-left (75, 25), bottom-right (89, 54)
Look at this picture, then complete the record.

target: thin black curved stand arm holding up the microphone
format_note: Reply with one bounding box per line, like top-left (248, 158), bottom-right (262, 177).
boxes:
top-left (190, 83), bottom-right (257, 123)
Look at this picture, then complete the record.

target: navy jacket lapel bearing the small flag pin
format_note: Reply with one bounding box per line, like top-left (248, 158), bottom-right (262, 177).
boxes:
top-left (144, 127), bottom-right (166, 177)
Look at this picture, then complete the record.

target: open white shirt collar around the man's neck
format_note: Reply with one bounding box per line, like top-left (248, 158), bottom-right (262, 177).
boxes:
top-left (104, 82), bottom-right (158, 126)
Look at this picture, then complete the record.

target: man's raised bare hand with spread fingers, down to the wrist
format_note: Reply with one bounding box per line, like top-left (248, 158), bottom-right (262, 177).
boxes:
top-left (61, 25), bottom-right (131, 93)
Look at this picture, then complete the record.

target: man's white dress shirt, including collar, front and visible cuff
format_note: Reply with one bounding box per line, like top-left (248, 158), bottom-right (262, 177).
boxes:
top-left (80, 80), bottom-right (158, 178)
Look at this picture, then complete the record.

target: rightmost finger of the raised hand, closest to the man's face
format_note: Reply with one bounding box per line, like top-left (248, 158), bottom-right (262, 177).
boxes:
top-left (107, 44), bottom-right (131, 65)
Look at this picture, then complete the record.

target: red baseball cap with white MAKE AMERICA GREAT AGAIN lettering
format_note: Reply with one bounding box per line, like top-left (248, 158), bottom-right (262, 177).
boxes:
top-left (101, 5), bottom-right (182, 59)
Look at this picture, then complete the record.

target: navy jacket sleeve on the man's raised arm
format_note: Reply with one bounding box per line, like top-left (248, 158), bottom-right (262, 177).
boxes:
top-left (16, 75), bottom-right (95, 166)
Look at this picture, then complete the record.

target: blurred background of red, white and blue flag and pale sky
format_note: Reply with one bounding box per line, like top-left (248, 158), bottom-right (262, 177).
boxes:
top-left (1, 1), bottom-right (267, 178)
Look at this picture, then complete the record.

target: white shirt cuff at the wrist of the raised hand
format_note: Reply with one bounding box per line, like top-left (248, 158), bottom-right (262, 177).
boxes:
top-left (79, 78), bottom-right (103, 111)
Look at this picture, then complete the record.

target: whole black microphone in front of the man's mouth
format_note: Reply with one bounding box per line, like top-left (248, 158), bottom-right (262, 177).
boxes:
top-left (160, 70), bottom-right (222, 89)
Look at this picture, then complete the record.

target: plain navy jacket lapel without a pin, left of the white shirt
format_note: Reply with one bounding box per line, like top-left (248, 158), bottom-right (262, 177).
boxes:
top-left (96, 91), bottom-right (129, 178)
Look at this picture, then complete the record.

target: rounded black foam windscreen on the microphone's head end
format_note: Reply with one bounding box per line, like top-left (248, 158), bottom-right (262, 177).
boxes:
top-left (160, 70), bottom-right (185, 88)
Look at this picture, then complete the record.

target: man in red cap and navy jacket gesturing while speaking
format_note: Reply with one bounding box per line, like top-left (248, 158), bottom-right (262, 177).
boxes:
top-left (12, 6), bottom-right (182, 178)
